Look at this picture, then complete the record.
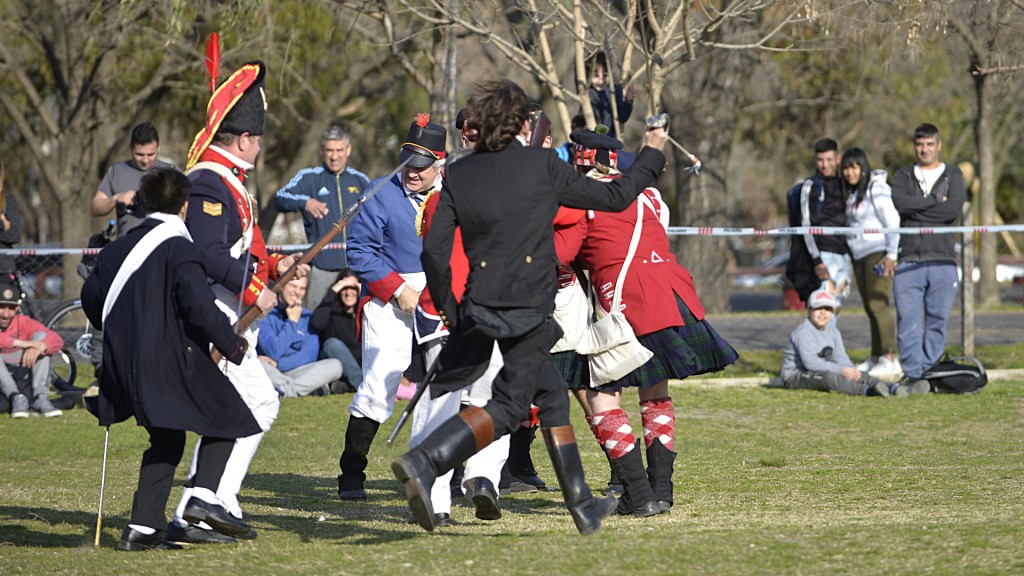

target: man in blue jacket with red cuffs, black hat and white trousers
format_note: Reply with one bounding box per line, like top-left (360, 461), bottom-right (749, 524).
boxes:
top-left (338, 113), bottom-right (447, 500)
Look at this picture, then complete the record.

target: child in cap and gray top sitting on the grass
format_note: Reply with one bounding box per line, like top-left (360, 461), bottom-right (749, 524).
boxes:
top-left (782, 289), bottom-right (929, 398)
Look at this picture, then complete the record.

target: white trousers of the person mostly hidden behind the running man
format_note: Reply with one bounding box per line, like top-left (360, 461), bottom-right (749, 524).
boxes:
top-left (409, 340), bottom-right (509, 513)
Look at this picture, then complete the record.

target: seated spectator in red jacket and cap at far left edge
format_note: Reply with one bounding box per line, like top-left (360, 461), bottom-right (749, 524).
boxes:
top-left (0, 274), bottom-right (63, 418)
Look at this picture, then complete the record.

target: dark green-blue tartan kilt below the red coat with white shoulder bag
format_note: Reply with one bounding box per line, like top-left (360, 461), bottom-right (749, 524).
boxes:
top-left (595, 296), bottom-right (739, 392)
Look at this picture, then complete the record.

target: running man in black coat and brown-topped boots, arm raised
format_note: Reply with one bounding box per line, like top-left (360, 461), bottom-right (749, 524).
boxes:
top-left (391, 80), bottom-right (668, 534)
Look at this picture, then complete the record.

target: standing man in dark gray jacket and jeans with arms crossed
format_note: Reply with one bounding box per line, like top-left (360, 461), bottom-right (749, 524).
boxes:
top-left (892, 124), bottom-right (966, 381)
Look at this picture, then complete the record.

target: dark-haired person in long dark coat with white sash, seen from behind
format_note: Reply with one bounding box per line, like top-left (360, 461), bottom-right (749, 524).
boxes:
top-left (82, 169), bottom-right (260, 550)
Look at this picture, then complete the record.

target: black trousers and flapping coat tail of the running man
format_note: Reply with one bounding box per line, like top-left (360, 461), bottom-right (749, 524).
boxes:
top-left (431, 319), bottom-right (569, 439)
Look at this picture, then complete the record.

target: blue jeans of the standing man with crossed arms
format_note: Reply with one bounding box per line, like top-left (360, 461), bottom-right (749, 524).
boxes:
top-left (893, 261), bottom-right (959, 378)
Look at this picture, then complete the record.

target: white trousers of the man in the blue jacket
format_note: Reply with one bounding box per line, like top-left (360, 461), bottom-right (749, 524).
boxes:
top-left (348, 298), bottom-right (413, 423)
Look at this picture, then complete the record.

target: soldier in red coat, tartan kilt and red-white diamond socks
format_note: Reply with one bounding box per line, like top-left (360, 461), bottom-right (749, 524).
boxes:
top-left (572, 130), bottom-right (738, 517)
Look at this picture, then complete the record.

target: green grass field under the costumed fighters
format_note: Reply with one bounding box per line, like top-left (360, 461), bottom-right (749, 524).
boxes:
top-left (0, 358), bottom-right (1024, 575)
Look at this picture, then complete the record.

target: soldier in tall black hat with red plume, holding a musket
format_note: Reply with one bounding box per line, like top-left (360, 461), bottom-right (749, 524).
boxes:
top-left (174, 61), bottom-right (309, 543)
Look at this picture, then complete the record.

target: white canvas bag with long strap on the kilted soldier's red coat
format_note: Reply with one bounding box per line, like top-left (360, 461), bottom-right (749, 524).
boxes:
top-left (578, 198), bottom-right (654, 386)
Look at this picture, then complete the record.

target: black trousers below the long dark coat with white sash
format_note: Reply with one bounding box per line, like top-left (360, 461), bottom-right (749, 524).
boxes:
top-left (130, 426), bottom-right (234, 530)
